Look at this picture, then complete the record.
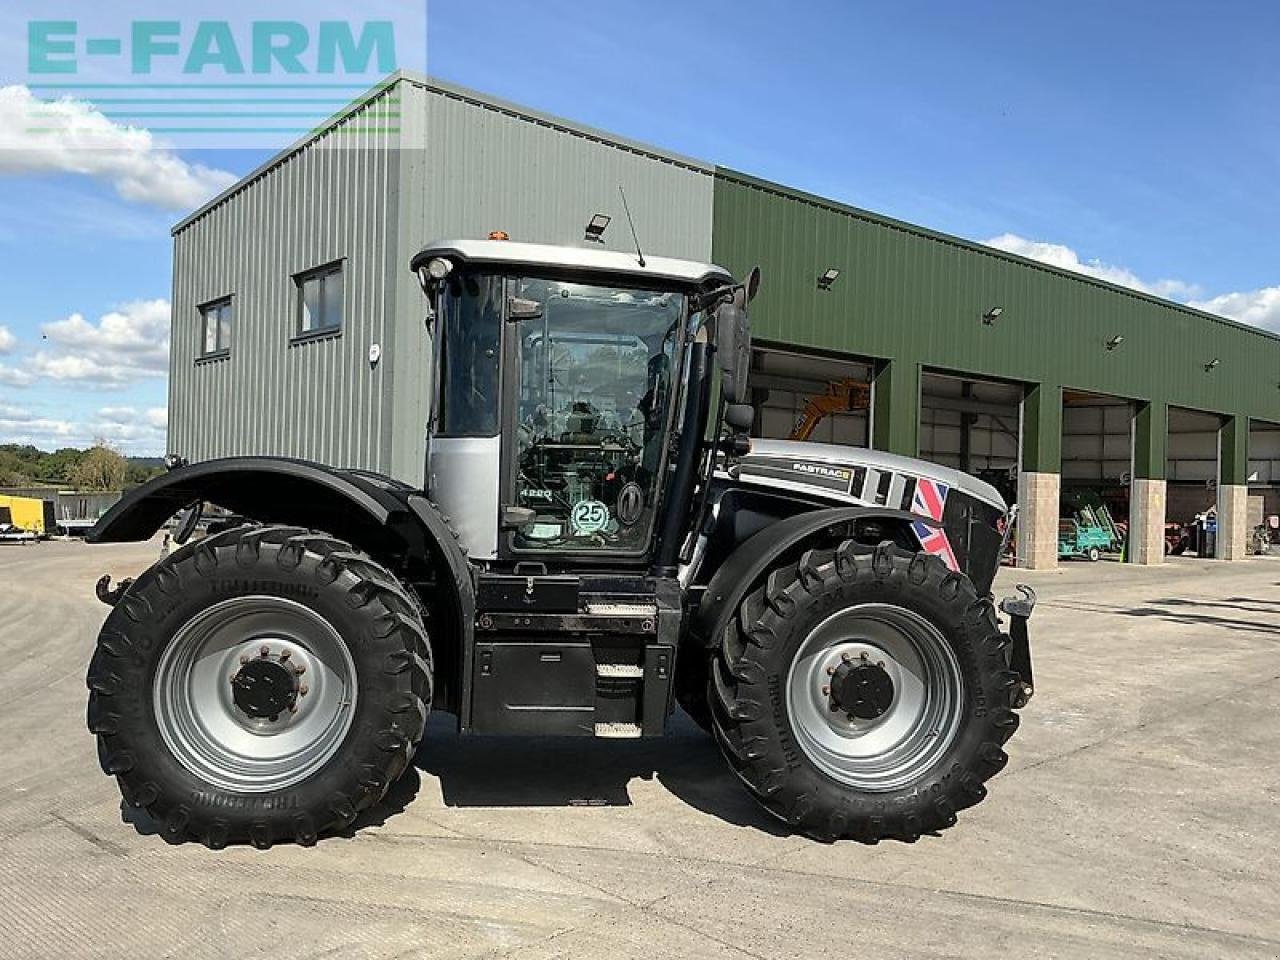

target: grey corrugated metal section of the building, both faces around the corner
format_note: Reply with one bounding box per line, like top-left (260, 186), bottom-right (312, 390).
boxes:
top-left (169, 79), bottom-right (713, 484)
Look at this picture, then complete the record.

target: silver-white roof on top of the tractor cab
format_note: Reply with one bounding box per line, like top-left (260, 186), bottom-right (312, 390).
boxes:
top-left (410, 239), bottom-right (733, 287)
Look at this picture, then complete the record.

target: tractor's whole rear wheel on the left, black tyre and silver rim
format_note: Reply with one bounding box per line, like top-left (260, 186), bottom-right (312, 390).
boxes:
top-left (88, 526), bottom-right (431, 847)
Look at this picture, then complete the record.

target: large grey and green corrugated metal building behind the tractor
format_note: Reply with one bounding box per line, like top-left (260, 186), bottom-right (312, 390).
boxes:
top-left (170, 74), bottom-right (1280, 566)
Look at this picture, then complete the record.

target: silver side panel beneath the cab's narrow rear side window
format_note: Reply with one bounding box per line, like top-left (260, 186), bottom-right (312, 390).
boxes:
top-left (428, 436), bottom-right (502, 559)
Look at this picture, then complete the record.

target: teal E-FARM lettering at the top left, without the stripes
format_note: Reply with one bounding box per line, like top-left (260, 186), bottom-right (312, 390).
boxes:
top-left (27, 20), bottom-right (397, 78)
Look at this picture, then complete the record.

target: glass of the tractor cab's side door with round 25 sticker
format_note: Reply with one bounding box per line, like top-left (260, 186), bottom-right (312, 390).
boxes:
top-left (512, 278), bottom-right (687, 553)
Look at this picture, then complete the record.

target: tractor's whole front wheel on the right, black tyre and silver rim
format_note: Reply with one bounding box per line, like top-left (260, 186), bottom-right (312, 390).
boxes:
top-left (709, 541), bottom-right (1019, 842)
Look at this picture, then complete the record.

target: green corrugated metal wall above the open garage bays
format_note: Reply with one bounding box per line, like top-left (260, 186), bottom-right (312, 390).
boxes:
top-left (713, 170), bottom-right (1280, 421)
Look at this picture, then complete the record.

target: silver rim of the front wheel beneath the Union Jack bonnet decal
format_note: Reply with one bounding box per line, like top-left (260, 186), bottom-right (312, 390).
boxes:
top-left (786, 604), bottom-right (964, 792)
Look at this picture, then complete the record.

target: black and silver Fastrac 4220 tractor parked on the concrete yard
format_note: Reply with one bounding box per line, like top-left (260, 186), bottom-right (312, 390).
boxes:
top-left (88, 239), bottom-right (1034, 847)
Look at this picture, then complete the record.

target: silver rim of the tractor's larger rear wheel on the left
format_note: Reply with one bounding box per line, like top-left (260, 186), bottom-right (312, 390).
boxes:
top-left (152, 596), bottom-right (356, 794)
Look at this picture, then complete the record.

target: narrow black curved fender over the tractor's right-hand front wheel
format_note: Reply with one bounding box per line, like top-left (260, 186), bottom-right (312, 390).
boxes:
top-left (692, 507), bottom-right (941, 648)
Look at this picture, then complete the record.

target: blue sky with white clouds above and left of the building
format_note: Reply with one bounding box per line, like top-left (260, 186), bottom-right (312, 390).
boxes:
top-left (0, 0), bottom-right (1280, 453)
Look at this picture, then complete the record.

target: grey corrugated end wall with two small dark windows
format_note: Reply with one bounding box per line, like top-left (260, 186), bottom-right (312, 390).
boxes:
top-left (169, 88), bottom-right (399, 470)
